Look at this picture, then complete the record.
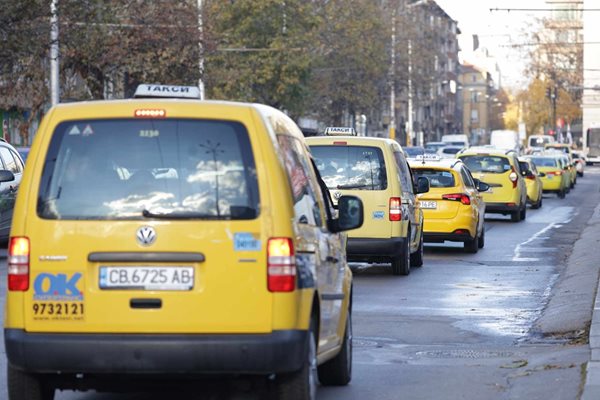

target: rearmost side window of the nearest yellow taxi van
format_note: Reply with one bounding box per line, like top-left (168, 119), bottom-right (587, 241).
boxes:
top-left (277, 135), bottom-right (323, 226)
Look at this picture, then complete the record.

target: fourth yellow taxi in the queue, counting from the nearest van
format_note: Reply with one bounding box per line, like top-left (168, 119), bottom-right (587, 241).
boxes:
top-left (457, 147), bottom-right (527, 222)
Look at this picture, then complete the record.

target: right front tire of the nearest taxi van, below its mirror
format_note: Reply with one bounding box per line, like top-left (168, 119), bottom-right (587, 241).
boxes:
top-left (317, 310), bottom-right (352, 386)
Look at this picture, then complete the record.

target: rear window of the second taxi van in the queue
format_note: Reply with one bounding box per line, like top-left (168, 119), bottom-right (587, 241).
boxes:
top-left (310, 146), bottom-right (387, 190)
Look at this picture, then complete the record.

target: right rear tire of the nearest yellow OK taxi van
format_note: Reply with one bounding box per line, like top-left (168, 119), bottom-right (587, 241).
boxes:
top-left (277, 319), bottom-right (319, 400)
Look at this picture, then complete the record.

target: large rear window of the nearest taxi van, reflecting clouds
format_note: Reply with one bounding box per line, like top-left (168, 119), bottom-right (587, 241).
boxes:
top-left (37, 119), bottom-right (259, 220)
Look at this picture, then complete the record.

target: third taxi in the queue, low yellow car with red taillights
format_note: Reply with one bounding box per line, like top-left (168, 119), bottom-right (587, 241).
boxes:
top-left (410, 155), bottom-right (489, 253)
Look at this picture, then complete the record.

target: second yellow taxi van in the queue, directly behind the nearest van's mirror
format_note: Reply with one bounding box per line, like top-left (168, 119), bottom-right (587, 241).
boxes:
top-left (306, 127), bottom-right (428, 275)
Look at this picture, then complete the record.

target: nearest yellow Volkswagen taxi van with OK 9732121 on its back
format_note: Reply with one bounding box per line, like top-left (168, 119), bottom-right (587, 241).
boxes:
top-left (4, 85), bottom-right (362, 400)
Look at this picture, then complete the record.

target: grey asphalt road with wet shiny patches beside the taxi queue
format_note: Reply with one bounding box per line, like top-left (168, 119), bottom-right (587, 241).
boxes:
top-left (0, 169), bottom-right (600, 400)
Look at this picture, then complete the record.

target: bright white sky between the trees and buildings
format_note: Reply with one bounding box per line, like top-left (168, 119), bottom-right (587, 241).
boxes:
top-left (436, 0), bottom-right (548, 89)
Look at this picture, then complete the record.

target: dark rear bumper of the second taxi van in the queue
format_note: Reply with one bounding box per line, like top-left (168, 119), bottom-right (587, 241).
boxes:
top-left (346, 237), bottom-right (408, 262)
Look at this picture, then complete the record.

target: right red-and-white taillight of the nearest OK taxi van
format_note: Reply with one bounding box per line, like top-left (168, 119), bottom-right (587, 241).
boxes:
top-left (267, 238), bottom-right (296, 292)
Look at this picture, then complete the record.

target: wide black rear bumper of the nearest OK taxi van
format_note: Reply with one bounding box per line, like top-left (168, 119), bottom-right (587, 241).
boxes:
top-left (4, 329), bottom-right (308, 374)
